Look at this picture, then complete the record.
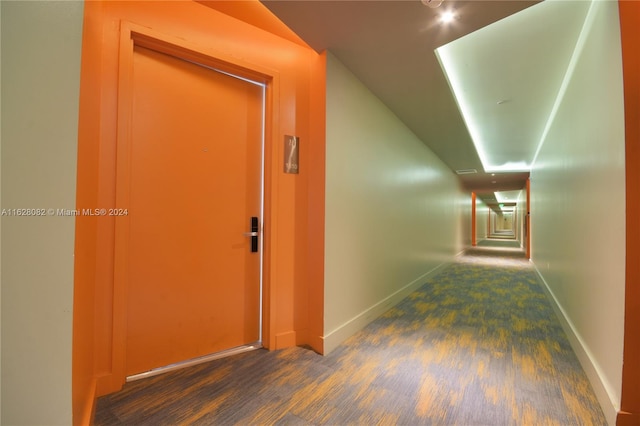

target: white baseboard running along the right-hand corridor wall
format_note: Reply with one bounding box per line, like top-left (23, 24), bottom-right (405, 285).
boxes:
top-left (532, 262), bottom-right (620, 426)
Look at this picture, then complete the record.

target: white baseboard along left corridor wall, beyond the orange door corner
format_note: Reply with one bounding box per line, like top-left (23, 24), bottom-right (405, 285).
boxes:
top-left (323, 262), bottom-right (450, 355)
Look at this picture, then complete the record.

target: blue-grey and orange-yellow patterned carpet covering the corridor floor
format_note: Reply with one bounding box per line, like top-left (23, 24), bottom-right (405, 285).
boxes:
top-left (95, 242), bottom-right (606, 425)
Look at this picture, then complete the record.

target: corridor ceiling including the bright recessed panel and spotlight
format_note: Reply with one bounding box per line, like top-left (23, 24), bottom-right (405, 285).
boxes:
top-left (261, 0), bottom-right (590, 206)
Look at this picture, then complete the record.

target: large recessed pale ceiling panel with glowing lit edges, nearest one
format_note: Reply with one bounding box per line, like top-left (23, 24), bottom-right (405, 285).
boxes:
top-left (436, 0), bottom-right (591, 172)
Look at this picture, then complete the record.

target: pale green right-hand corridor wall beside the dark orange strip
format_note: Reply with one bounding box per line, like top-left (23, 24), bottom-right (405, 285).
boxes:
top-left (531, 1), bottom-right (625, 424)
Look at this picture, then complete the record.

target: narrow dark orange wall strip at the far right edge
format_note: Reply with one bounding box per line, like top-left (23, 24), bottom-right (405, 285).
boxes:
top-left (617, 0), bottom-right (640, 425)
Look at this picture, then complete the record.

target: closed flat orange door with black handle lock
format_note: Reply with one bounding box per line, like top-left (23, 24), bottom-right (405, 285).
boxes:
top-left (126, 46), bottom-right (264, 375)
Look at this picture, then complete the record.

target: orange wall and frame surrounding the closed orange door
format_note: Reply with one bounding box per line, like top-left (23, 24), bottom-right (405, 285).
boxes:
top-left (73, 1), bottom-right (325, 424)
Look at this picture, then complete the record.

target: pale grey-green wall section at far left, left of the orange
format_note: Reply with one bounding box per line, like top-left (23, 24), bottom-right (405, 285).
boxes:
top-left (0, 1), bottom-right (83, 425)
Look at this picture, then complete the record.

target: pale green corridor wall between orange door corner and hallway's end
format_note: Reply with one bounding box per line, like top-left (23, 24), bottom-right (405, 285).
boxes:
top-left (324, 54), bottom-right (470, 352)
